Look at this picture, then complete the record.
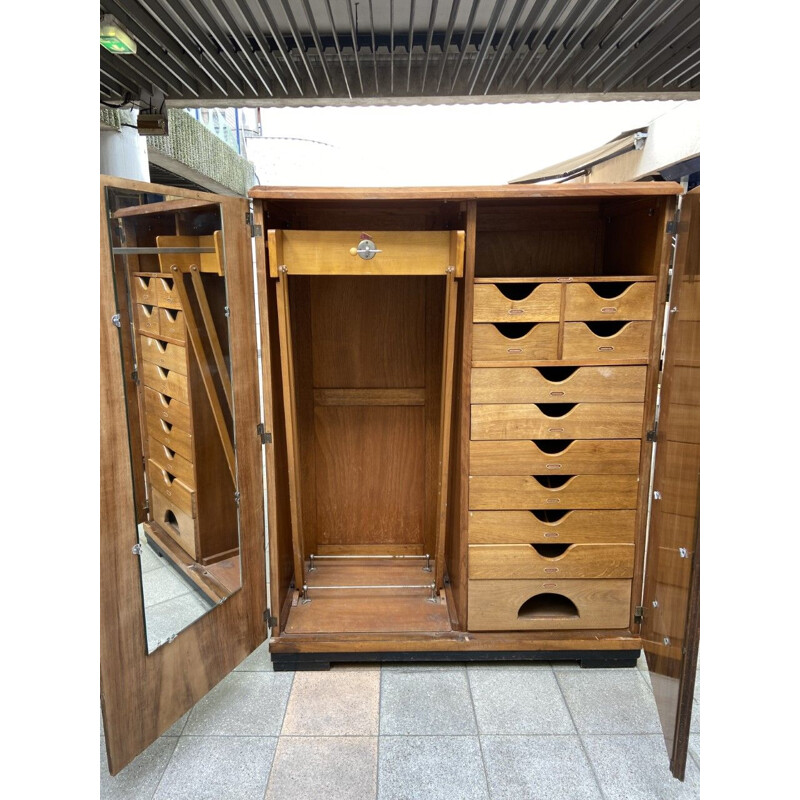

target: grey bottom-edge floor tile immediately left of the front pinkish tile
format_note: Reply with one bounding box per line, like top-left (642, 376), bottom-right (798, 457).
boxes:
top-left (154, 736), bottom-right (278, 800)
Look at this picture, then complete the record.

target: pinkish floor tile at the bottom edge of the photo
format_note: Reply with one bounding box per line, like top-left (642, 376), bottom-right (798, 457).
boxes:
top-left (265, 736), bottom-right (378, 800)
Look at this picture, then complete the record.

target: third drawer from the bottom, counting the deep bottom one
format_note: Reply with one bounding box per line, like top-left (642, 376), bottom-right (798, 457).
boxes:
top-left (469, 509), bottom-right (636, 544)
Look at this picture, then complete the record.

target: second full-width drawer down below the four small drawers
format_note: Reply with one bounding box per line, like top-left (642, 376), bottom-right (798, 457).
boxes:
top-left (471, 403), bottom-right (644, 439)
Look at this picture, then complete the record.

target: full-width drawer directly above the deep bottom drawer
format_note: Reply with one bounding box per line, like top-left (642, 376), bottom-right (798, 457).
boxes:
top-left (469, 543), bottom-right (634, 580)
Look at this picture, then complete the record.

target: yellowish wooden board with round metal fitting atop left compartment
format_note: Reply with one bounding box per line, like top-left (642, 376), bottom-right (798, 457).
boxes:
top-left (275, 230), bottom-right (463, 277)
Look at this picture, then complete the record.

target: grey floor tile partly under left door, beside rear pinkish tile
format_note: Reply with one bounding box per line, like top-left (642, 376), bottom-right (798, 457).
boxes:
top-left (183, 672), bottom-right (293, 736)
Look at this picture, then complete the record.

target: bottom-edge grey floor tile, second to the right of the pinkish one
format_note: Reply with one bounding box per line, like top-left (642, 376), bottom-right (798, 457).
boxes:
top-left (481, 736), bottom-right (603, 800)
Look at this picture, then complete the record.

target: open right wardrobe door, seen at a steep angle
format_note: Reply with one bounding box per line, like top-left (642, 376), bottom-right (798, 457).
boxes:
top-left (642, 187), bottom-right (700, 780)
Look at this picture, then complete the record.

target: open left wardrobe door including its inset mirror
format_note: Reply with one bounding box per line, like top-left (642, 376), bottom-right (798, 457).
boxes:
top-left (100, 178), bottom-right (267, 774)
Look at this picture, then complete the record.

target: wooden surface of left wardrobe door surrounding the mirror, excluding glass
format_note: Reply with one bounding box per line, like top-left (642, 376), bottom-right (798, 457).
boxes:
top-left (100, 177), bottom-right (271, 774)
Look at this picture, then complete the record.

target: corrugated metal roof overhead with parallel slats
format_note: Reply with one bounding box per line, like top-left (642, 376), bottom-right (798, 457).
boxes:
top-left (100, 0), bottom-right (700, 106)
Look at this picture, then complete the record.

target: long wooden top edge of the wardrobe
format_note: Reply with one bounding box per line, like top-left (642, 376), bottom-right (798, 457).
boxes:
top-left (249, 181), bottom-right (683, 201)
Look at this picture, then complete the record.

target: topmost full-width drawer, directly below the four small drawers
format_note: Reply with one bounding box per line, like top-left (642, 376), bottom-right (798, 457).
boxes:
top-left (470, 367), bottom-right (647, 403)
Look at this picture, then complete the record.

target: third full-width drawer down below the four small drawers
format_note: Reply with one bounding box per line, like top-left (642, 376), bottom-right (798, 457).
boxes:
top-left (469, 439), bottom-right (641, 475)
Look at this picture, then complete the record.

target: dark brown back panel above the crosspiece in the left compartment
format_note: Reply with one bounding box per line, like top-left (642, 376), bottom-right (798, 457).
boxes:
top-left (311, 277), bottom-right (425, 389)
